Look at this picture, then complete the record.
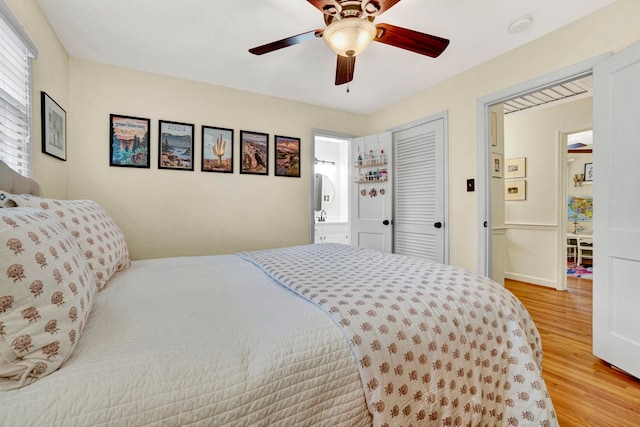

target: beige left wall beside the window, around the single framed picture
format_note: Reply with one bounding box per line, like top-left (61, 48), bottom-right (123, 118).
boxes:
top-left (4, 0), bottom-right (70, 199)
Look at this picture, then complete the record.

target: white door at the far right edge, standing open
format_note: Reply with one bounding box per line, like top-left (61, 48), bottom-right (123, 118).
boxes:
top-left (593, 40), bottom-right (640, 378)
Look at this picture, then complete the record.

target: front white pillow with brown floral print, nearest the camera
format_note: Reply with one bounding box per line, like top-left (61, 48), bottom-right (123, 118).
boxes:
top-left (0, 207), bottom-right (97, 389)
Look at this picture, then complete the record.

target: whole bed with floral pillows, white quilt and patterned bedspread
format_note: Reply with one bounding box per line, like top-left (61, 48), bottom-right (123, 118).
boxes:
top-left (0, 162), bottom-right (557, 426)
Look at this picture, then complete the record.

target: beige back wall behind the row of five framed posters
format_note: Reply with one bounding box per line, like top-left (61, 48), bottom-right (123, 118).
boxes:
top-left (69, 58), bottom-right (364, 259)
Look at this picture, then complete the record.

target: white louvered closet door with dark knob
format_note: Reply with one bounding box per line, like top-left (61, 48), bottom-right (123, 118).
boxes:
top-left (393, 119), bottom-right (446, 263)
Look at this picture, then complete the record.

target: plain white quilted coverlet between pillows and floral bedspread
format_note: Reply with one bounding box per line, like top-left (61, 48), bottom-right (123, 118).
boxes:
top-left (0, 255), bottom-right (371, 427)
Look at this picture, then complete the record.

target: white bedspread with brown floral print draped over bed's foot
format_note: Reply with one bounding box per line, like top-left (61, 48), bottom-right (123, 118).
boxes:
top-left (238, 244), bottom-right (558, 426)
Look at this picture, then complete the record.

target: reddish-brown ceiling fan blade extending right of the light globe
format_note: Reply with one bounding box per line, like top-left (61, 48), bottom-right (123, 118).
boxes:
top-left (373, 24), bottom-right (449, 58)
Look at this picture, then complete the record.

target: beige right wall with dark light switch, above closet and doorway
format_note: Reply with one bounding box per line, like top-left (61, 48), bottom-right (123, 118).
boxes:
top-left (367, 0), bottom-right (640, 271)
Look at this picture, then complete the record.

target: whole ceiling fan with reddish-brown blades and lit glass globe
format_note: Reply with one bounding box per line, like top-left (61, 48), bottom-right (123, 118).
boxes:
top-left (249, 0), bottom-right (449, 85)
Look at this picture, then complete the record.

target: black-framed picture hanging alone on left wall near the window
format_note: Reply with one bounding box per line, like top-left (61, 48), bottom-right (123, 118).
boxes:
top-left (40, 91), bottom-right (67, 161)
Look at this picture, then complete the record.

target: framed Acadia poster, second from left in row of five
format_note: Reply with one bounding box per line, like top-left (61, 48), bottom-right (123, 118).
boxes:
top-left (158, 120), bottom-right (194, 171)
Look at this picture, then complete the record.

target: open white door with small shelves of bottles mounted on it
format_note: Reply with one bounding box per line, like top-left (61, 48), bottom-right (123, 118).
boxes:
top-left (351, 132), bottom-right (393, 253)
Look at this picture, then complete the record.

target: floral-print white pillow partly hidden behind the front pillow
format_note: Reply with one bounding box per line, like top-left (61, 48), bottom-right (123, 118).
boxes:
top-left (11, 194), bottom-right (131, 290)
